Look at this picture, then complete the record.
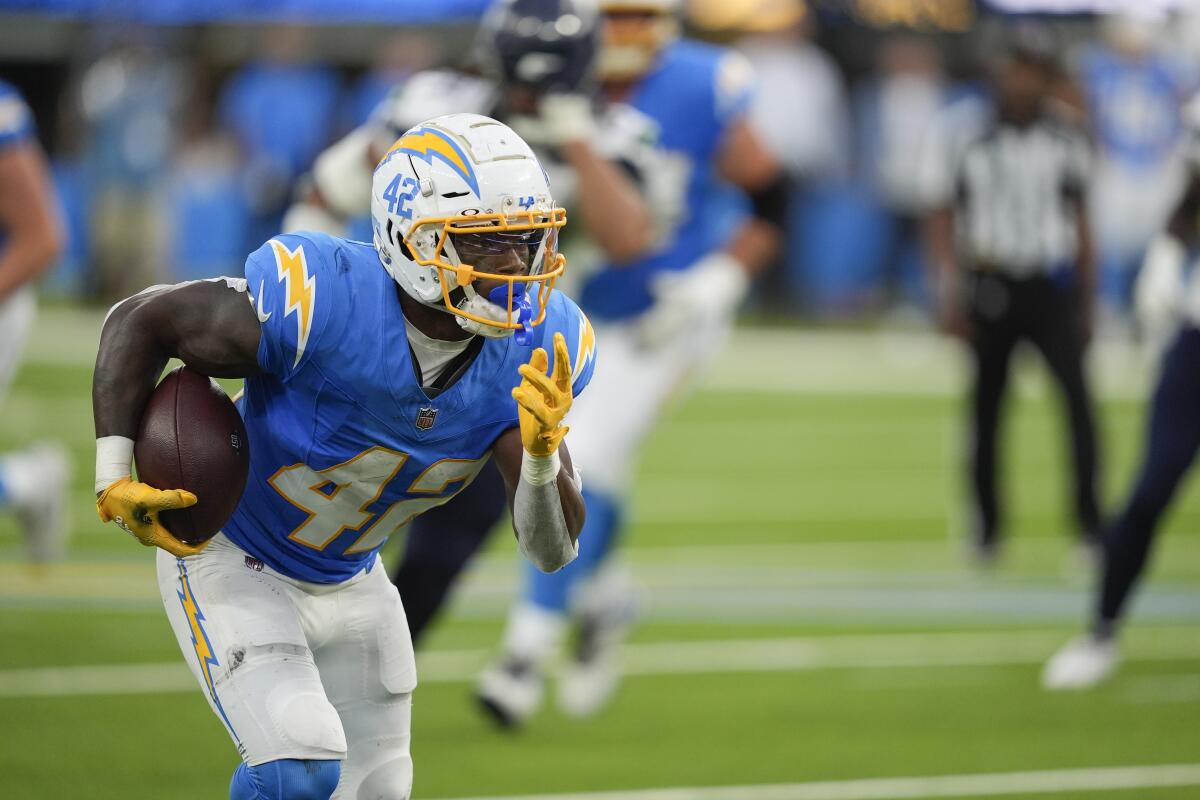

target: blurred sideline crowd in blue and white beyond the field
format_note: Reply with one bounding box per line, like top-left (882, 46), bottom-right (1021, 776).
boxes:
top-left (7, 0), bottom-right (1200, 319)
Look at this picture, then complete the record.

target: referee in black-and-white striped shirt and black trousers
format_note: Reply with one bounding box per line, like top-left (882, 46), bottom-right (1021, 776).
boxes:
top-left (925, 29), bottom-right (1100, 565)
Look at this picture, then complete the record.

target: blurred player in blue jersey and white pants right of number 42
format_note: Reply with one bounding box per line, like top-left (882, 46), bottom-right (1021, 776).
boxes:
top-left (478, 0), bottom-right (787, 726)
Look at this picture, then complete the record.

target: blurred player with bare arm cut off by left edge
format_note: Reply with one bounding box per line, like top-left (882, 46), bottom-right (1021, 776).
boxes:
top-left (0, 74), bottom-right (67, 561)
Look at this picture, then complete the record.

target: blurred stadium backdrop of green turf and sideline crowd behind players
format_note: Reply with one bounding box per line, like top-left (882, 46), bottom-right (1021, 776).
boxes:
top-left (0, 0), bottom-right (1200, 800)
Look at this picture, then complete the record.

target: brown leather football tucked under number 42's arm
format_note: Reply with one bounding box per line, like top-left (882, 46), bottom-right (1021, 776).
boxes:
top-left (133, 367), bottom-right (250, 545)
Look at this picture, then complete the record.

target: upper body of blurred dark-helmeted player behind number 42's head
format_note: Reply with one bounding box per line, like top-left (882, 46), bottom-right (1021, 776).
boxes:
top-left (283, 0), bottom-right (655, 261)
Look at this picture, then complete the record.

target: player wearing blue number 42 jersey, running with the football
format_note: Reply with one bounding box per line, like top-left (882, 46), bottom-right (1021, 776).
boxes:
top-left (92, 114), bottom-right (595, 800)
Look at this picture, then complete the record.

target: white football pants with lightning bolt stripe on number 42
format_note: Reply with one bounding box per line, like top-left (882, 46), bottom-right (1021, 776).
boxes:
top-left (158, 534), bottom-right (416, 800)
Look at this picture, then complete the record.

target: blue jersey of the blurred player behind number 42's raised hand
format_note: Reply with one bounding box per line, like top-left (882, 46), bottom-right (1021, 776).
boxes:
top-left (580, 40), bottom-right (751, 320)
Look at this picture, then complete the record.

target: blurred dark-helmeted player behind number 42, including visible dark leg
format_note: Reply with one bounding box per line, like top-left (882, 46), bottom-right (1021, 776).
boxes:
top-left (284, 0), bottom-right (658, 643)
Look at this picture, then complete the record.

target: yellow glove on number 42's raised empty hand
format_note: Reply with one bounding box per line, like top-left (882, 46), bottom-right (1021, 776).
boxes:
top-left (512, 333), bottom-right (571, 457)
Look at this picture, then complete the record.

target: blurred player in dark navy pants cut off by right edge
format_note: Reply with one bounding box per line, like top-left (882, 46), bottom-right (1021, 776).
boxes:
top-left (1042, 97), bottom-right (1200, 690)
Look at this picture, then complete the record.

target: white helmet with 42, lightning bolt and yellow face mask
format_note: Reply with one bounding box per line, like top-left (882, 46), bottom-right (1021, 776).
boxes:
top-left (371, 114), bottom-right (566, 338)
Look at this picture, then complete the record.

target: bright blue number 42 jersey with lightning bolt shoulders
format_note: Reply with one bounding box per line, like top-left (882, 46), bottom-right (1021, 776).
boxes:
top-left (224, 233), bottom-right (595, 583)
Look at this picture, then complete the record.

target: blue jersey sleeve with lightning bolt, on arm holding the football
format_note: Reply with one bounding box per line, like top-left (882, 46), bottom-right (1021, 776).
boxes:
top-left (246, 234), bottom-right (350, 380)
